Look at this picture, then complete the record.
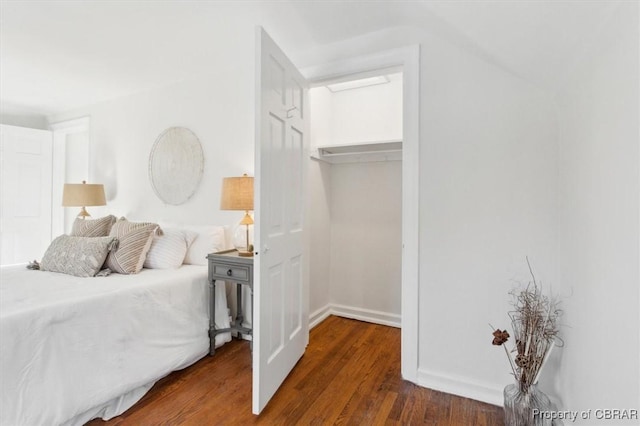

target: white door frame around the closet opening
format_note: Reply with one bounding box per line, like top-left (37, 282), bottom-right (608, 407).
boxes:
top-left (301, 45), bottom-right (420, 383)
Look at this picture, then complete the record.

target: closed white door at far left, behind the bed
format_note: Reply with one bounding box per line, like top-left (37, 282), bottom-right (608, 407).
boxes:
top-left (0, 125), bottom-right (53, 265)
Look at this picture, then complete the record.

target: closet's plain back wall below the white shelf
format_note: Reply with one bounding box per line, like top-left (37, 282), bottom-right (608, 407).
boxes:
top-left (329, 161), bottom-right (402, 318)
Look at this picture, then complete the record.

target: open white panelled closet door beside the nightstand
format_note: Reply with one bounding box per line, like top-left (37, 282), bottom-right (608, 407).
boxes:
top-left (253, 28), bottom-right (309, 414)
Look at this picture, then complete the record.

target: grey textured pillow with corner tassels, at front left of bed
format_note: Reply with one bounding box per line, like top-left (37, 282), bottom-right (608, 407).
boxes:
top-left (40, 235), bottom-right (115, 277)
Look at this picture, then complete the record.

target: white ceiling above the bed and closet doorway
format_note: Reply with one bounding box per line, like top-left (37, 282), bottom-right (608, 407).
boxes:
top-left (0, 0), bottom-right (621, 115)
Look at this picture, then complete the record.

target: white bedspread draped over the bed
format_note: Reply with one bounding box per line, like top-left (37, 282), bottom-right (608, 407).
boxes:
top-left (0, 265), bottom-right (230, 425)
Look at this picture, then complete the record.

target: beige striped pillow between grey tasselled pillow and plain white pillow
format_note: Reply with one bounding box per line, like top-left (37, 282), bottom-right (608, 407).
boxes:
top-left (106, 217), bottom-right (162, 274)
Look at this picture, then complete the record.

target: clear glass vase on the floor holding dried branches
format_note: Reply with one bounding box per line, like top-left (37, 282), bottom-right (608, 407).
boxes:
top-left (504, 383), bottom-right (552, 426)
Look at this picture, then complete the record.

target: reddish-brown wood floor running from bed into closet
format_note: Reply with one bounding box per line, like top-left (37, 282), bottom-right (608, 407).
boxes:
top-left (88, 316), bottom-right (504, 426)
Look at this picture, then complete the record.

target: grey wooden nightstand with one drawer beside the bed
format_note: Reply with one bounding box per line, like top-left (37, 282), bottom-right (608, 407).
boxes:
top-left (207, 250), bottom-right (253, 355)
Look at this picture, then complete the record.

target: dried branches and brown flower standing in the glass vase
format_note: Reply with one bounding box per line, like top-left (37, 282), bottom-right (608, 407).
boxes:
top-left (491, 259), bottom-right (562, 393)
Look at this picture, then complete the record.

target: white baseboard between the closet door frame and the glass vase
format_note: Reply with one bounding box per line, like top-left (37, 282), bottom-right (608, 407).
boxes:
top-left (418, 369), bottom-right (504, 407)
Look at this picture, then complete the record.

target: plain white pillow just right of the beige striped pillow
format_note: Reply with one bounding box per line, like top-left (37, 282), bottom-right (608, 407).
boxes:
top-left (144, 228), bottom-right (198, 269)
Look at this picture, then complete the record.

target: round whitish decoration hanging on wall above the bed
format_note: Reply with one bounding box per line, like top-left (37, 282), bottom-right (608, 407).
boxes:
top-left (149, 127), bottom-right (204, 205)
